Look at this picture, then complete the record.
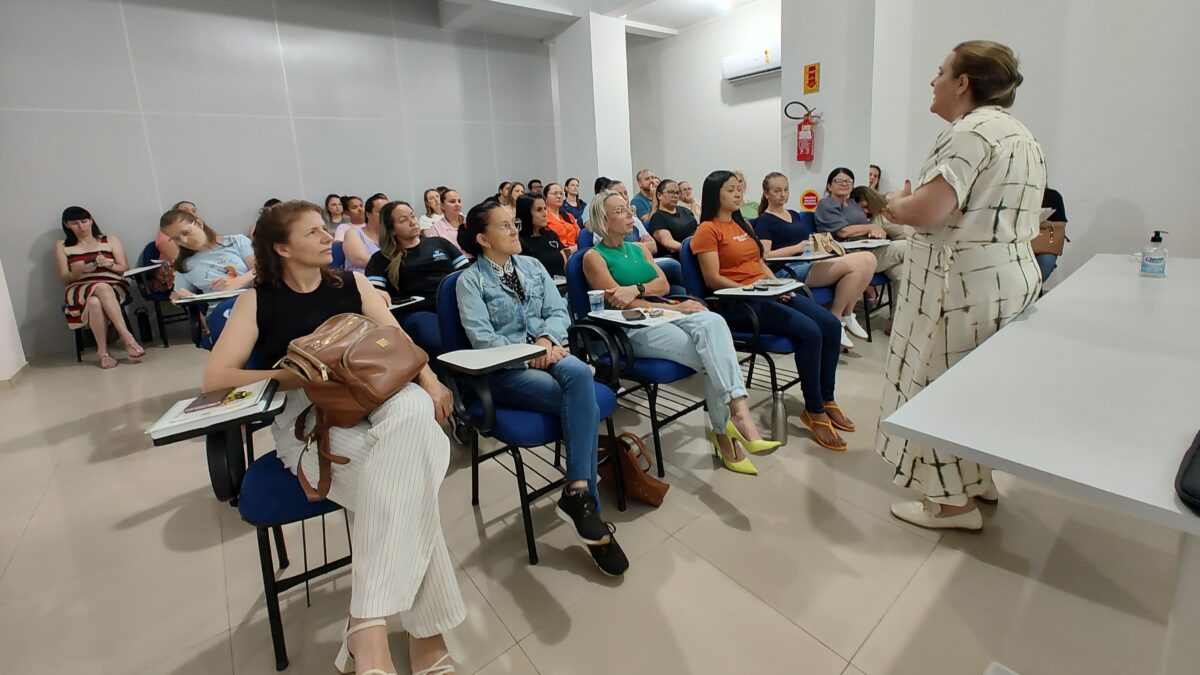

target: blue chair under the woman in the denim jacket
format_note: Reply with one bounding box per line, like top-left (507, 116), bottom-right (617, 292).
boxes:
top-left (437, 271), bottom-right (625, 565)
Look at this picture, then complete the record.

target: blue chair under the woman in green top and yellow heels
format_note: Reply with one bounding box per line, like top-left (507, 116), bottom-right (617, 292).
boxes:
top-left (566, 247), bottom-right (704, 477)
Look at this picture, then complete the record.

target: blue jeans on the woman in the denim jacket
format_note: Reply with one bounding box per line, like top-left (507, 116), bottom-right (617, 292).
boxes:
top-left (487, 355), bottom-right (600, 513)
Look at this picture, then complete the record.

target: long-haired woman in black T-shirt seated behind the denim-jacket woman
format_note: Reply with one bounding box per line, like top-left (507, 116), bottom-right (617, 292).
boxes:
top-left (364, 202), bottom-right (469, 357)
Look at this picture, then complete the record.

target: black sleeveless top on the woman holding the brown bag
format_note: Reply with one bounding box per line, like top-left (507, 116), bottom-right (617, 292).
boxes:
top-left (254, 271), bottom-right (362, 368)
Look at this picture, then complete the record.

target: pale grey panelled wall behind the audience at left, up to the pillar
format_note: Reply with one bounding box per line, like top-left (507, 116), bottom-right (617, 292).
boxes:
top-left (0, 0), bottom-right (557, 356)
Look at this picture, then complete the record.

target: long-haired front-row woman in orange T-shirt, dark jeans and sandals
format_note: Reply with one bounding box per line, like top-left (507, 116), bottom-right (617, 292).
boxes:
top-left (691, 171), bottom-right (854, 450)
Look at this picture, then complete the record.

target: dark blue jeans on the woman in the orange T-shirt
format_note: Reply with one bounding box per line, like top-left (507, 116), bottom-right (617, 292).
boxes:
top-left (719, 294), bottom-right (841, 413)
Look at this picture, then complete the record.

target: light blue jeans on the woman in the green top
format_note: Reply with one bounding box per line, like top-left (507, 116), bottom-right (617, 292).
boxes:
top-left (629, 312), bottom-right (746, 434)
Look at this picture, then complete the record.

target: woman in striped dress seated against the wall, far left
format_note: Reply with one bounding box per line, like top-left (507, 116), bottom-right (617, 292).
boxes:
top-left (54, 207), bottom-right (146, 369)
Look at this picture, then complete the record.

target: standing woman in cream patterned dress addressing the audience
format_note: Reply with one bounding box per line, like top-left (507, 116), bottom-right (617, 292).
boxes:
top-left (877, 40), bottom-right (1046, 530)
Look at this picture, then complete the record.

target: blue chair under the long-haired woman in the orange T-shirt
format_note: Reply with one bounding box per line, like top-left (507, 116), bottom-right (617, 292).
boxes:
top-left (679, 237), bottom-right (808, 443)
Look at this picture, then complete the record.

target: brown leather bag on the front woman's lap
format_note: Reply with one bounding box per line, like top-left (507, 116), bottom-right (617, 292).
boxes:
top-left (275, 313), bottom-right (430, 502)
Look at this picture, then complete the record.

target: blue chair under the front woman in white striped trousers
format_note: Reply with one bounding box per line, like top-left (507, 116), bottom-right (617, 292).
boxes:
top-left (205, 298), bottom-right (352, 670)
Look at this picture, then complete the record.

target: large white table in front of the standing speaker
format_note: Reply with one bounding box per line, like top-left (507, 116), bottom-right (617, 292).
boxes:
top-left (882, 255), bottom-right (1200, 675)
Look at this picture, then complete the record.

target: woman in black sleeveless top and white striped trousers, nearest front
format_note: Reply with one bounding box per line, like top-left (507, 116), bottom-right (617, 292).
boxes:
top-left (204, 202), bottom-right (467, 673)
